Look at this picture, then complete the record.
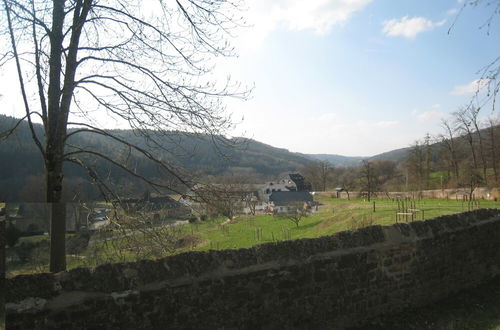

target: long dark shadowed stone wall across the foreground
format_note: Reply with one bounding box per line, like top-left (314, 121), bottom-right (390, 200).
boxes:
top-left (6, 210), bottom-right (500, 329)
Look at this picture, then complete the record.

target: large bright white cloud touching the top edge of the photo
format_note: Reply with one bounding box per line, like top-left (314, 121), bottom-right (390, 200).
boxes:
top-left (236, 0), bottom-right (373, 51)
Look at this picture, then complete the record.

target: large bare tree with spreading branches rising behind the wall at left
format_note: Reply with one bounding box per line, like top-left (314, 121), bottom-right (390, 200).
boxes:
top-left (0, 0), bottom-right (246, 272)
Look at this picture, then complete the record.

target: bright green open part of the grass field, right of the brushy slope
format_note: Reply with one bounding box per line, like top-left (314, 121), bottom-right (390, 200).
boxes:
top-left (185, 195), bottom-right (500, 250)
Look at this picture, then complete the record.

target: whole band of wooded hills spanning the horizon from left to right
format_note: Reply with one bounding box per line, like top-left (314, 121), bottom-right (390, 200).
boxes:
top-left (0, 110), bottom-right (500, 201)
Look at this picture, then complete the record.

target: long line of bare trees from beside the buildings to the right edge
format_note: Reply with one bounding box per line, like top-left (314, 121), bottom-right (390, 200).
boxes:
top-left (302, 107), bottom-right (500, 195)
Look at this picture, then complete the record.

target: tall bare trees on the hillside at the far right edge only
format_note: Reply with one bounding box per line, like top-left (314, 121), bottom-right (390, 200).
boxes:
top-left (405, 107), bottom-right (500, 189)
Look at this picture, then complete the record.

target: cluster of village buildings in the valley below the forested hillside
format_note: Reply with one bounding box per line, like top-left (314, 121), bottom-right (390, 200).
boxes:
top-left (4, 173), bottom-right (319, 235)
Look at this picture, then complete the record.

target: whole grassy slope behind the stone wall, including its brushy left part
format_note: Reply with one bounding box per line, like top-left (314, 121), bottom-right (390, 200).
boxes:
top-left (7, 194), bottom-right (500, 276)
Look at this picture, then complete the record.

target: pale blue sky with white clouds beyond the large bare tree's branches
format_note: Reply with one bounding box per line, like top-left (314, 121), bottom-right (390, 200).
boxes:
top-left (0, 0), bottom-right (500, 156)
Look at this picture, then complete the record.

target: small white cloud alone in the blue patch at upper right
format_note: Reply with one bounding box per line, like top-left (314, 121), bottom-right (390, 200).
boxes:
top-left (382, 16), bottom-right (446, 38)
